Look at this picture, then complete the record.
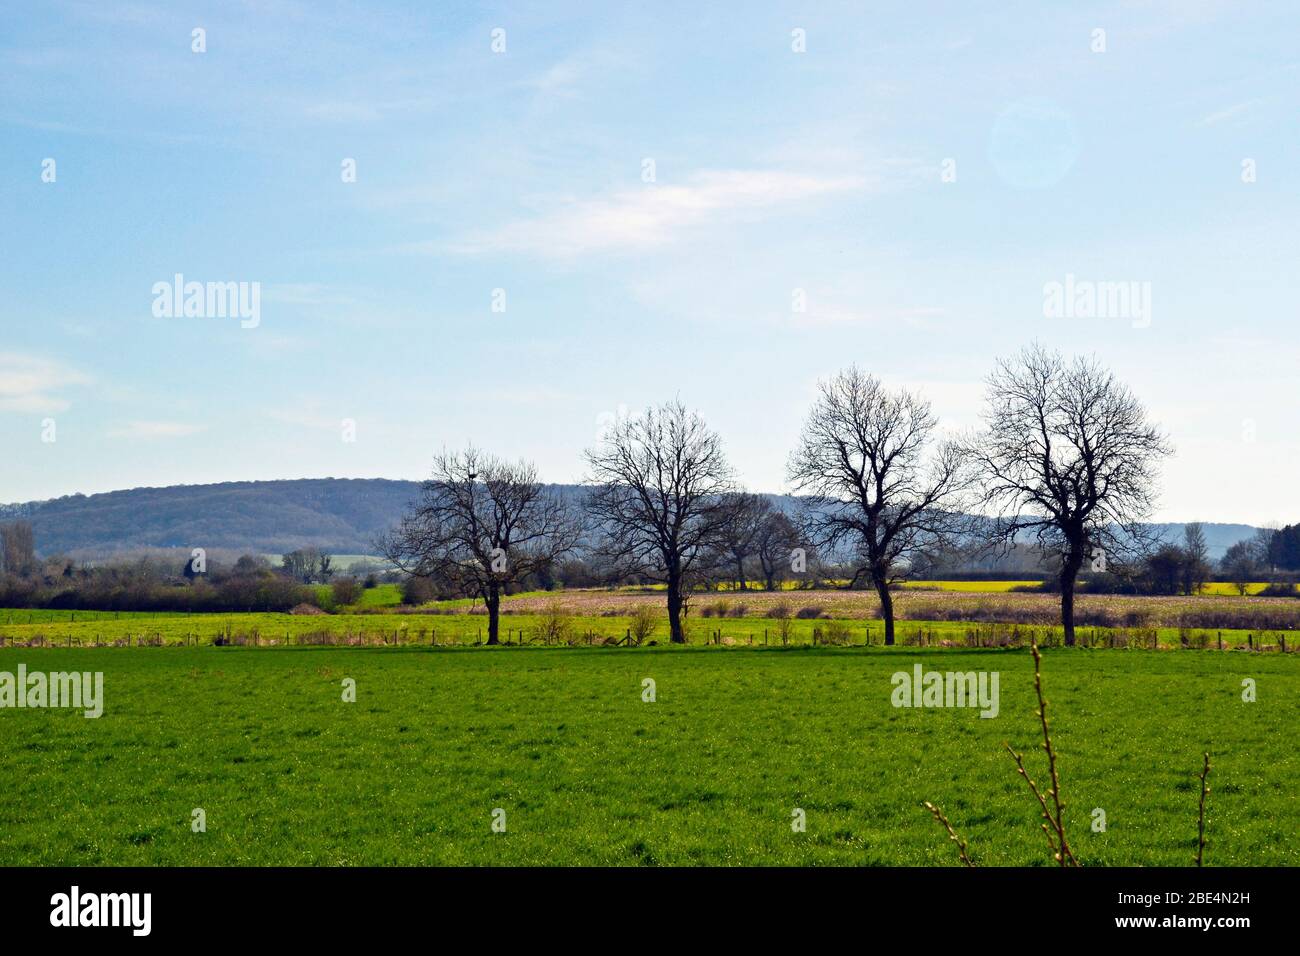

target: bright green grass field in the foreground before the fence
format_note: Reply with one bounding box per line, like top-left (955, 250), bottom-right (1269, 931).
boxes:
top-left (0, 646), bottom-right (1300, 865)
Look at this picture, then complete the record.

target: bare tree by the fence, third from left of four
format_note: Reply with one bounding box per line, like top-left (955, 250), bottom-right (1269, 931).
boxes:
top-left (788, 367), bottom-right (963, 644)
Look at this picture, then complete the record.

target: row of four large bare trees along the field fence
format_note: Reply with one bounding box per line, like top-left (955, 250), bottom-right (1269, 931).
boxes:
top-left (381, 346), bottom-right (1170, 644)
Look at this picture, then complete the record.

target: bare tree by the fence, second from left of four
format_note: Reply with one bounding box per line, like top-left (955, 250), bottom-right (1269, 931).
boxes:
top-left (586, 401), bottom-right (741, 644)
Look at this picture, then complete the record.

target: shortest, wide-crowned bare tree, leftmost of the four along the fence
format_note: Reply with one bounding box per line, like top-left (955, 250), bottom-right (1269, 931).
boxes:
top-left (380, 447), bottom-right (581, 644)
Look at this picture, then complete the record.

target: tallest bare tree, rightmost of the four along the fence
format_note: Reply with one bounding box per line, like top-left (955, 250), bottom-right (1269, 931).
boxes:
top-left (967, 345), bottom-right (1173, 645)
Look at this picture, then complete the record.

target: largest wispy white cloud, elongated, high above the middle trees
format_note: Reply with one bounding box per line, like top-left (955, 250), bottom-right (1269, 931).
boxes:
top-left (443, 169), bottom-right (867, 258)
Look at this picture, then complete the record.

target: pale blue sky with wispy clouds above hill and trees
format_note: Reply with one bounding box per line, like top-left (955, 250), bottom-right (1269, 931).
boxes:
top-left (0, 0), bottom-right (1300, 523)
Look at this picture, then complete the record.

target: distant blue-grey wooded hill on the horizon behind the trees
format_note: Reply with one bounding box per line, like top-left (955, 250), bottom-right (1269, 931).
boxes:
top-left (0, 479), bottom-right (1255, 558)
